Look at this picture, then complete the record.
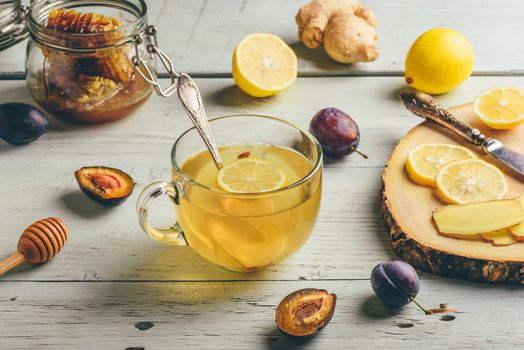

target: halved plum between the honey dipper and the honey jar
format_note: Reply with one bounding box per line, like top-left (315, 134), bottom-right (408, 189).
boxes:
top-left (75, 166), bottom-right (135, 206)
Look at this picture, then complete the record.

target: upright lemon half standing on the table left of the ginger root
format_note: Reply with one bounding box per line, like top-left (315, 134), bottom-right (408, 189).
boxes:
top-left (233, 33), bottom-right (298, 97)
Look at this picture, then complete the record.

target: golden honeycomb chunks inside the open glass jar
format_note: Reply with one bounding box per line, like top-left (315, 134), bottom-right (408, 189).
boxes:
top-left (44, 9), bottom-right (134, 82)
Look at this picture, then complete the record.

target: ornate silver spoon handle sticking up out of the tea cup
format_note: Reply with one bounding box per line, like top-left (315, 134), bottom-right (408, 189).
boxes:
top-left (177, 73), bottom-right (224, 169)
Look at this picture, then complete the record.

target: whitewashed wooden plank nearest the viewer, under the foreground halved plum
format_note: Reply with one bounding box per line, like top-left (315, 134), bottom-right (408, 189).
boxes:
top-left (0, 279), bottom-right (524, 350)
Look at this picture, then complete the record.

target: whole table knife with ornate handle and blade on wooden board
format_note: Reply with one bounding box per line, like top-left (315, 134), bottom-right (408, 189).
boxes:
top-left (400, 91), bottom-right (524, 176)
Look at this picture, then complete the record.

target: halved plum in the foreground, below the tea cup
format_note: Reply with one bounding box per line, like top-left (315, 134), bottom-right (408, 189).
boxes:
top-left (276, 288), bottom-right (337, 337)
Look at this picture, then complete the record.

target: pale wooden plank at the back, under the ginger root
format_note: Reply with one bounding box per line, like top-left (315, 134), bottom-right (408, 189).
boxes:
top-left (0, 0), bottom-right (524, 75)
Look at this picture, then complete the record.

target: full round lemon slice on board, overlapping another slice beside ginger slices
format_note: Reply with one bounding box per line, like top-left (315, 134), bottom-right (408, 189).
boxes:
top-left (436, 159), bottom-right (508, 204)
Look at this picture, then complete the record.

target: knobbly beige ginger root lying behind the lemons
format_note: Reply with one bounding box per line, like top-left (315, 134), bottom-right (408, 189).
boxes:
top-left (295, 0), bottom-right (379, 63)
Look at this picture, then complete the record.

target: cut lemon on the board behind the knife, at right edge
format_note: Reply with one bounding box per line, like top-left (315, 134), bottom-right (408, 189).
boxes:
top-left (474, 87), bottom-right (524, 129)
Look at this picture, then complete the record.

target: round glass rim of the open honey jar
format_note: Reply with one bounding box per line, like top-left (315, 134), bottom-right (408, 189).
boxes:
top-left (26, 0), bottom-right (147, 52)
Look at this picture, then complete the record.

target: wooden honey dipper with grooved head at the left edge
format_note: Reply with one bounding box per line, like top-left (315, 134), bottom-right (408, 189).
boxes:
top-left (0, 218), bottom-right (67, 275)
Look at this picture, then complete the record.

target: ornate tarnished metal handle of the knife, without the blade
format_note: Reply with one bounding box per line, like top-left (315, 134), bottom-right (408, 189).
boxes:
top-left (400, 91), bottom-right (490, 150)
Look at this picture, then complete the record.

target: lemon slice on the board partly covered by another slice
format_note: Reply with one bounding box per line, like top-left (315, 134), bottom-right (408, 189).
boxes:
top-left (406, 143), bottom-right (476, 187)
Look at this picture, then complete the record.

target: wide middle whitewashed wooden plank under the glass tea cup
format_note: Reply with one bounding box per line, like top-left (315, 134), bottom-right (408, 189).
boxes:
top-left (0, 77), bottom-right (521, 280)
